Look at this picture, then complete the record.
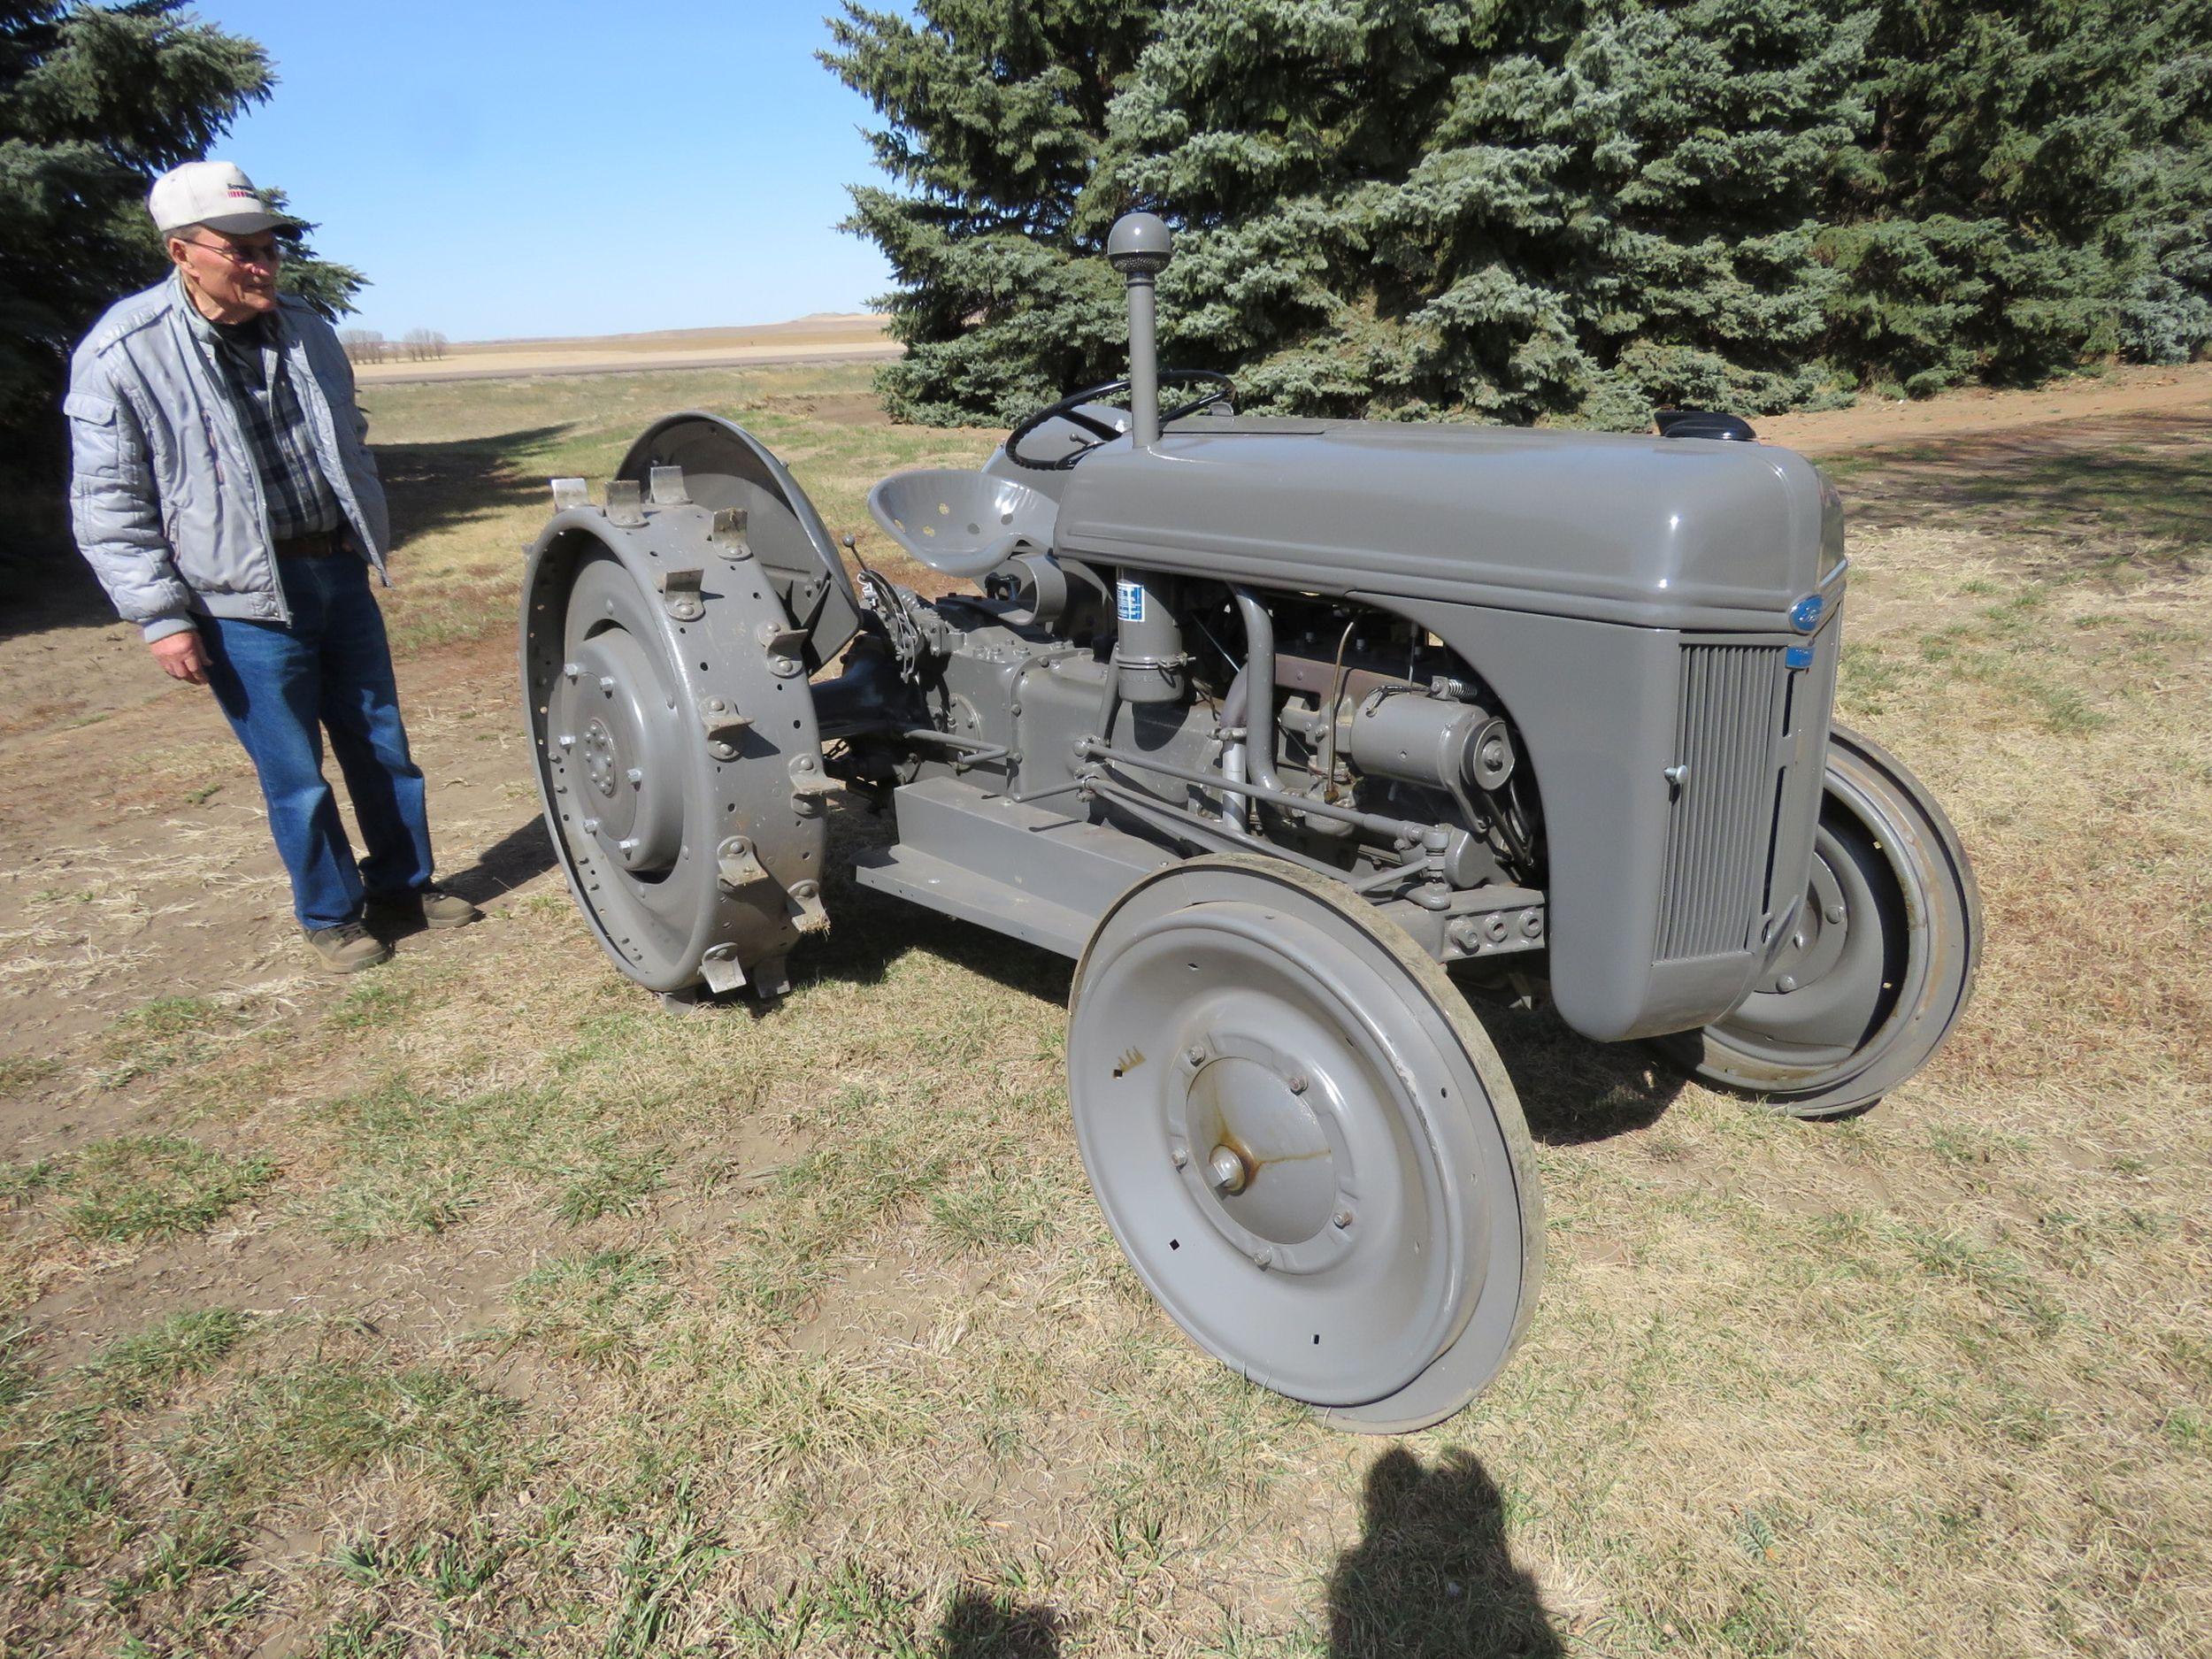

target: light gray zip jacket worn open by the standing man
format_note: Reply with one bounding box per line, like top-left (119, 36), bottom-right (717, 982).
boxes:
top-left (62, 277), bottom-right (392, 641)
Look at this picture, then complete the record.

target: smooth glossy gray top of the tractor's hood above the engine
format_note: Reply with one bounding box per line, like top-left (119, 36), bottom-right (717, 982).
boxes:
top-left (1056, 419), bottom-right (1843, 631)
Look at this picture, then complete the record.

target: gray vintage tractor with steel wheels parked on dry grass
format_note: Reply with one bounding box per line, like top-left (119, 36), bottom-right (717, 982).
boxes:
top-left (522, 215), bottom-right (1980, 1432)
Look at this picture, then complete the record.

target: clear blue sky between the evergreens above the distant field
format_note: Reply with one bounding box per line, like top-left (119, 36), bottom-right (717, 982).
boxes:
top-left (197, 0), bottom-right (889, 341)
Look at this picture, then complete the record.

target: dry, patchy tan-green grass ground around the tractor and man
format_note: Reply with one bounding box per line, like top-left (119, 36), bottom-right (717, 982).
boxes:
top-left (0, 367), bottom-right (2212, 1659)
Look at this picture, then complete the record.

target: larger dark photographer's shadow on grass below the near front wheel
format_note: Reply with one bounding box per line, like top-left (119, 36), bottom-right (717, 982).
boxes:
top-left (1330, 1447), bottom-right (1566, 1659)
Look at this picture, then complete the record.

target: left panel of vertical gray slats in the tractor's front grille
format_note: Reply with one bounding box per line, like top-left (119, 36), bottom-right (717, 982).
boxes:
top-left (1657, 646), bottom-right (1783, 963)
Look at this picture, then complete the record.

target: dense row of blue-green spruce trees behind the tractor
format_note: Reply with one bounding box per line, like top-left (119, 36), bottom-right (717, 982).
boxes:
top-left (826, 0), bottom-right (2212, 427)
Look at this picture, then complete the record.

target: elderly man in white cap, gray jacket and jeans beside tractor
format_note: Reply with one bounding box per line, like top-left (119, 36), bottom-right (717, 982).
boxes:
top-left (65, 162), bottom-right (478, 973)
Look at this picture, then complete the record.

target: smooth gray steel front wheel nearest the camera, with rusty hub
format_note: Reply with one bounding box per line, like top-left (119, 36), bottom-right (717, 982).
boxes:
top-left (1069, 858), bottom-right (1542, 1432)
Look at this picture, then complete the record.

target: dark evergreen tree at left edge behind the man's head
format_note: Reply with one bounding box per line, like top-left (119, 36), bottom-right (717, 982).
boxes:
top-left (0, 0), bottom-right (363, 463)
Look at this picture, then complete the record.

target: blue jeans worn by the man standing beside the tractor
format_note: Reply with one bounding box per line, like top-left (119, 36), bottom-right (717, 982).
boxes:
top-left (195, 553), bottom-right (432, 929)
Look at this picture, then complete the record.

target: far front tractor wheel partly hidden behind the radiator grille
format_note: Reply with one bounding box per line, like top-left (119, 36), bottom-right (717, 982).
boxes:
top-left (1659, 726), bottom-right (1982, 1118)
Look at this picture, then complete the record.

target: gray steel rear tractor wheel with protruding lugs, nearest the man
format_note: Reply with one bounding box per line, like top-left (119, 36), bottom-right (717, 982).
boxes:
top-left (522, 484), bottom-right (827, 994)
